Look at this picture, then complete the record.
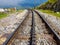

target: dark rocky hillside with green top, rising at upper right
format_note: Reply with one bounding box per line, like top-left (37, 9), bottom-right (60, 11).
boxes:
top-left (37, 0), bottom-right (60, 11)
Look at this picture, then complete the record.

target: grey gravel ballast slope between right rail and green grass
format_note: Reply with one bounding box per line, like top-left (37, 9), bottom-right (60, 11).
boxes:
top-left (36, 10), bottom-right (60, 35)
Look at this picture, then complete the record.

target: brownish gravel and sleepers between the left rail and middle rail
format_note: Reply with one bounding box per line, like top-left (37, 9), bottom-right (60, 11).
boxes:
top-left (5, 12), bottom-right (32, 45)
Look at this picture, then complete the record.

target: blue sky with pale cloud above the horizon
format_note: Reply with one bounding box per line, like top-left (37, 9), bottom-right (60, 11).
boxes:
top-left (0, 0), bottom-right (47, 8)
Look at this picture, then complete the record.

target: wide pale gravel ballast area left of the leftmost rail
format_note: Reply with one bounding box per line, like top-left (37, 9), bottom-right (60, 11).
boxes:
top-left (0, 10), bottom-right (28, 45)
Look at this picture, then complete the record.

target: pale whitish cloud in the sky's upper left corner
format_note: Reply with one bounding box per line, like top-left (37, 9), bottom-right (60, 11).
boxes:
top-left (0, 0), bottom-right (23, 6)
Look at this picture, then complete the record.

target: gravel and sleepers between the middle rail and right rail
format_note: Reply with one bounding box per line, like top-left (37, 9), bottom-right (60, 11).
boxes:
top-left (34, 11), bottom-right (57, 45)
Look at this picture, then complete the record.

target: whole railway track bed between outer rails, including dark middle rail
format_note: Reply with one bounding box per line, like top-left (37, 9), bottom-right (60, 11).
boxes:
top-left (5, 10), bottom-right (60, 45)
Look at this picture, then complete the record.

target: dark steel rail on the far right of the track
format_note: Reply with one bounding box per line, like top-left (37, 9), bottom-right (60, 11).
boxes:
top-left (34, 10), bottom-right (60, 45)
